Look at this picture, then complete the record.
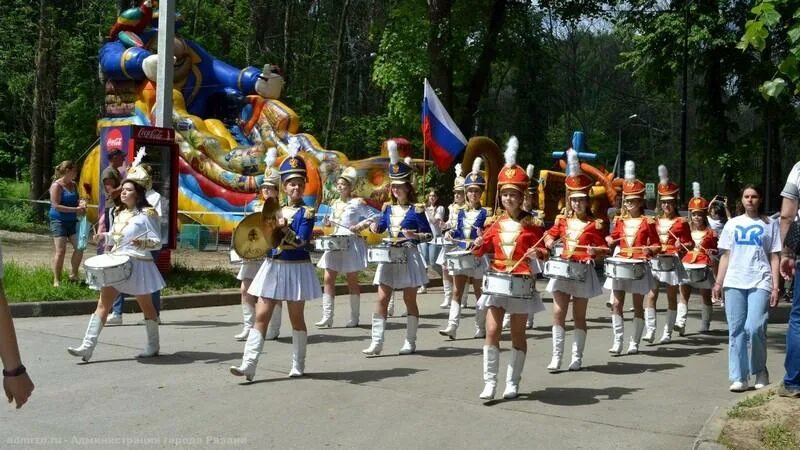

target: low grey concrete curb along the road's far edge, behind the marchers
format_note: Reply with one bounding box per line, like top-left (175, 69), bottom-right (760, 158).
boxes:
top-left (8, 278), bottom-right (442, 318)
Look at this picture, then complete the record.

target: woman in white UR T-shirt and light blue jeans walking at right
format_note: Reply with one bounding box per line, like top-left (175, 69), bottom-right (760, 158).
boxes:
top-left (711, 185), bottom-right (781, 392)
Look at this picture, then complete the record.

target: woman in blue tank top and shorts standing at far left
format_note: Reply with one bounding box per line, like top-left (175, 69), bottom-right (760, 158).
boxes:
top-left (48, 161), bottom-right (86, 287)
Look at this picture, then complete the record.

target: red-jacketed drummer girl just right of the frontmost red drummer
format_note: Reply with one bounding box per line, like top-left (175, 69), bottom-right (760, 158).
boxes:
top-left (544, 149), bottom-right (608, 371)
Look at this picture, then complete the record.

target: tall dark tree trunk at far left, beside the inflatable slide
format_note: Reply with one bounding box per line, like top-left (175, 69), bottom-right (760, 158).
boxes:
top-left (30, 0), bottom-right (58, 221)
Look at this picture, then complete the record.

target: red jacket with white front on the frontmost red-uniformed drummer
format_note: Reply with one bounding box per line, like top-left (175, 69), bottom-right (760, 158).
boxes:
top-left (472, 211), bottom-right (546, 275)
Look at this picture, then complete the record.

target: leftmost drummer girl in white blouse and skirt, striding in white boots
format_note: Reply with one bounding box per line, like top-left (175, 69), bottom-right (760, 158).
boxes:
top-left (67, 160), bottom-right (164, 361)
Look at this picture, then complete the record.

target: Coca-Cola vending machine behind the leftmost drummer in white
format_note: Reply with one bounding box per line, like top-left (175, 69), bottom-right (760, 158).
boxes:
top-left (98, 125), bottom-right (178, 253)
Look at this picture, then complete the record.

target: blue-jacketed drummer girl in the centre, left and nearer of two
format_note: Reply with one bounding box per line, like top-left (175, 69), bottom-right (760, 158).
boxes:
top-left (361, 141), bottom-right (431, 356)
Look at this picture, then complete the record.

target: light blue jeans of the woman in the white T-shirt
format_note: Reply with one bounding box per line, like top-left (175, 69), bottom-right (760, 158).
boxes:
top-left (725, 288), bottom-right (770, 383)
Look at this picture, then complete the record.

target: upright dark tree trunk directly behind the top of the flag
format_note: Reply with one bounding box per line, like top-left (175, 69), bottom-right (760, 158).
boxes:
top-left (428, 0), bottom-right (453, 114)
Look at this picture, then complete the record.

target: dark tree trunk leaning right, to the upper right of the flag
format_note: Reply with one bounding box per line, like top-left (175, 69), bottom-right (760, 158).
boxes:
top-left (459, 0), bottom-right (507, 136)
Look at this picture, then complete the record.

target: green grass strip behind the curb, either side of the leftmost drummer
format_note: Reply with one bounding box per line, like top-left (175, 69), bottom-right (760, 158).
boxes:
top-left (4, 261), bottom-right (239, 303)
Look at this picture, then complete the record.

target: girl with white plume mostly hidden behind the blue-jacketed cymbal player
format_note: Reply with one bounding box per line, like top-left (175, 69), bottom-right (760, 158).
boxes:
top-left (231, 147), bottom-right (283, 341)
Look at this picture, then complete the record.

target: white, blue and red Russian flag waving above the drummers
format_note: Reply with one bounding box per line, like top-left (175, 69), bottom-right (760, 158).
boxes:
top-left (422, 78), bottom-right (467, 171)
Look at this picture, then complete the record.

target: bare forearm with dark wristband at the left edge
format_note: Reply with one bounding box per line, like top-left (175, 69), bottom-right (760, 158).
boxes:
top-left (0, 246), bottom-right (33, 409)
